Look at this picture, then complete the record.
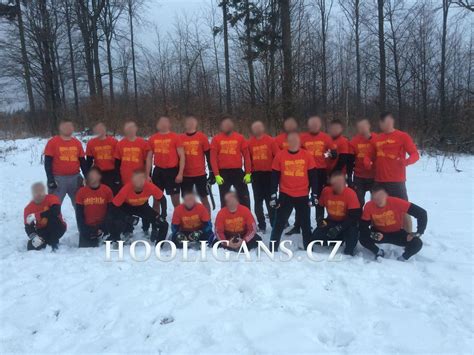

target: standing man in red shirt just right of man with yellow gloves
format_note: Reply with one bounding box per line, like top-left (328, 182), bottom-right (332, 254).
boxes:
top-left (248, 121), bottom-right (279, 233)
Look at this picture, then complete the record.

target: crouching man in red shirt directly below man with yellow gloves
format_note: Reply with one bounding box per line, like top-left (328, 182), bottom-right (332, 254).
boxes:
top-left (216, 192), bottom-right (262, 251)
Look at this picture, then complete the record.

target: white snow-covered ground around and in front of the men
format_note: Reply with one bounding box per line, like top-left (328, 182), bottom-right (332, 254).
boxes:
top-left (0, 139), bottom-right (474, 354)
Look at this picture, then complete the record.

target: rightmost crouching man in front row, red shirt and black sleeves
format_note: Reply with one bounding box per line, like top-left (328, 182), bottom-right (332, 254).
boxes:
top-left (359, 185), bottom-right (428, 261)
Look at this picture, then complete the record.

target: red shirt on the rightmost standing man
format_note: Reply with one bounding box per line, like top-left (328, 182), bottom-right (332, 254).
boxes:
top-left (364, 129), bottom-right (420, 182)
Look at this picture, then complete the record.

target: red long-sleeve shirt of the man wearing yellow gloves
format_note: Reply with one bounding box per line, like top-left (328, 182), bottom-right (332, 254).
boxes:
top-left (211, 132), bottom-right (251, 175)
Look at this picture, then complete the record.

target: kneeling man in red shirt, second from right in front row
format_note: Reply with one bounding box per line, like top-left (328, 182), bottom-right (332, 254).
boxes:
top-left (313, 171), bottom-right (361, 255)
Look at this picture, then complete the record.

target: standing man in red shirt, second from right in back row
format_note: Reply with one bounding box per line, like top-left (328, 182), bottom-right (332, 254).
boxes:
top-left (348, 118), bottom-right (377, 206)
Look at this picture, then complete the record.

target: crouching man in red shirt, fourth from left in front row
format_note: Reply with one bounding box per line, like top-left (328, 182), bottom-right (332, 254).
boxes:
top-left (171, 192), bottom-right (214, 248)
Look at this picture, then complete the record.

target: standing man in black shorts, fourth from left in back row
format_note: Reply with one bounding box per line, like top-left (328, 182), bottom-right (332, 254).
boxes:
top-left (147, 116), bottom-right (185, 212)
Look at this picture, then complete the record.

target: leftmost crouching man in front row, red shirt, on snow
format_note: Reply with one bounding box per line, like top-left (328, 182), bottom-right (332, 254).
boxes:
top-left (24, 182), bottom-right (66, 250)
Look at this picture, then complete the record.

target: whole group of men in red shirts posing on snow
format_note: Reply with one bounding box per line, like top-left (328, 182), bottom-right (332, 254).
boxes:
top-left (24, 113), bottom-right (427, 260)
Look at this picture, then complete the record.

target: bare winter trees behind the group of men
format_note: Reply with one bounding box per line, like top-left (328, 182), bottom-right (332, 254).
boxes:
top-left (0, 0), bottom-right (474, 151)
